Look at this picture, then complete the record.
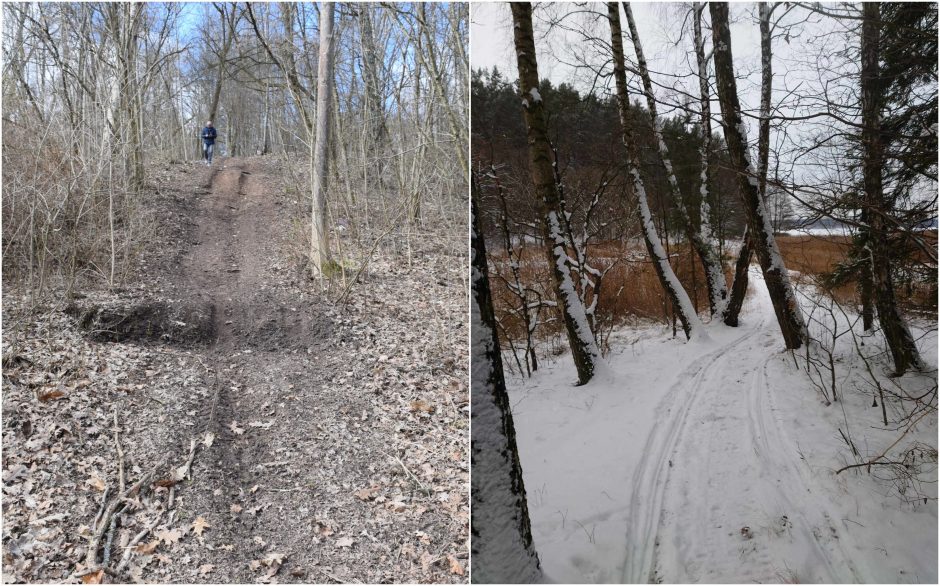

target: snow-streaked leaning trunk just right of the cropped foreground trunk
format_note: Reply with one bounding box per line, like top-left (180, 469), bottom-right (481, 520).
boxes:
top-left (510, 2), bottom-right (601, 384)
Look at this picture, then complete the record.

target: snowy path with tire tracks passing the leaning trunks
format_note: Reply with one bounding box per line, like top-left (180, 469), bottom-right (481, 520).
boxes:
top-left (652, 320), bottom-right (859, 583)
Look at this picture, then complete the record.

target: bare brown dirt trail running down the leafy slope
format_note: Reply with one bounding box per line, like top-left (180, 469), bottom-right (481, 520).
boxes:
top-left (173, 159), bottom-right (348, 582)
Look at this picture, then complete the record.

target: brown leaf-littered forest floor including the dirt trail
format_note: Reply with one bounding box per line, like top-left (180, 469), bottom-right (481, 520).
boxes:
top-left (3, 158), bottom-right (469, 583)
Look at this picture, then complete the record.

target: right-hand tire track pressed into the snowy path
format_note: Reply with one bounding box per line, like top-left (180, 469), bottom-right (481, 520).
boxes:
top-left (748, 356), bottom-right (863, 582)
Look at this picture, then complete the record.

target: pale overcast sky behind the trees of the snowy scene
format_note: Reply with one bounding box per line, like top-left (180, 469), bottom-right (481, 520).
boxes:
top-left (470, 2), bottom-right (857, 206)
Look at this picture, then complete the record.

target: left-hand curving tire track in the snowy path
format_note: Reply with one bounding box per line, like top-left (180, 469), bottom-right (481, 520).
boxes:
top-left (621, 319), bottom-right (764, 584)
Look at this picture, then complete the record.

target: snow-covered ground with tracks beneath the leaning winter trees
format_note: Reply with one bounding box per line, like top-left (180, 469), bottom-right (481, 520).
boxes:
top-left (509, 267), bottom-right (937, 583)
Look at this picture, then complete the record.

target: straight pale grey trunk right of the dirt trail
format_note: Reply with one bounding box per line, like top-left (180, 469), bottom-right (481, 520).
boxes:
top-left (310, 2), bottom-right (335, 278)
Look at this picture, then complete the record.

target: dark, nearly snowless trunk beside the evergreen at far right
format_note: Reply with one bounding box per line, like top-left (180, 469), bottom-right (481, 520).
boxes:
top-left (861, 3), bottom-right (924, 375)
